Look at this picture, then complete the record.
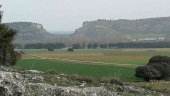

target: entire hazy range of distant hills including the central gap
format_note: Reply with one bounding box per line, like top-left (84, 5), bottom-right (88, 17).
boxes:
top-left (5, 17), bottom-right (170, 46)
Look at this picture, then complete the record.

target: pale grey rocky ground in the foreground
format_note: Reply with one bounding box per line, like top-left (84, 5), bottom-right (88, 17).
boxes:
top-left (0, 67), bottom-right (165, 96)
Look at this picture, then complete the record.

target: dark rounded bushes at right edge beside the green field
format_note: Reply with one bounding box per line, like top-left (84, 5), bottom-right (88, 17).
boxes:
top-left (136, 56), bottom-right (170, 81)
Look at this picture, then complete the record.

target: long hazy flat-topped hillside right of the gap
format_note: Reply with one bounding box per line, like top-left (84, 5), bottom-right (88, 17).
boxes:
top-left (71, 17), bottom-right (170, 42)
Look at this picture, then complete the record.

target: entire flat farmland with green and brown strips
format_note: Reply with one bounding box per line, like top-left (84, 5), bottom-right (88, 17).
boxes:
top-left (16, 49), bottom-right (170, 81)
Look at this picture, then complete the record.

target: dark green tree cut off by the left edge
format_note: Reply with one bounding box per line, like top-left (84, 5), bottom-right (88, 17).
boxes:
top-left (0, 6), bottom-right (17, 66)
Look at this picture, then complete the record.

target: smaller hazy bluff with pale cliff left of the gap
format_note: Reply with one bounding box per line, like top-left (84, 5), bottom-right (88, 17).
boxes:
top-left (5, 22), bottom-right (49, 42)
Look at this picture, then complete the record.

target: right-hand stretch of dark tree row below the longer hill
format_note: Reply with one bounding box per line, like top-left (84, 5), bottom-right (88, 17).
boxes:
top-left (73, 42), bottom-right (170, 49)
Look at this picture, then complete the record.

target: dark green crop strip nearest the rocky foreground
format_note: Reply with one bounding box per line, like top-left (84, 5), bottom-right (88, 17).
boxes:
top-left (15, 59), bottom-right (142, 81)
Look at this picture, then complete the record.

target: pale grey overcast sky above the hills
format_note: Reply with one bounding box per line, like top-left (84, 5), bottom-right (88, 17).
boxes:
top-left (0, 0), bottom-right (170, 31)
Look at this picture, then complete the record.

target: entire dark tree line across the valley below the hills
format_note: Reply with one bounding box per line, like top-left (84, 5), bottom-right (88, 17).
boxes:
top-left (15, 42), bottom-right (170, 49)
